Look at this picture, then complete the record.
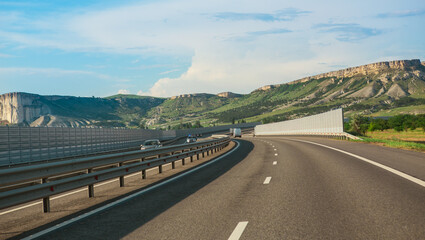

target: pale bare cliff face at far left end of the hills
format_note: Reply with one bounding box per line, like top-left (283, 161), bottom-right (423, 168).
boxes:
top-left (0, 92), bottom-right (51, 124)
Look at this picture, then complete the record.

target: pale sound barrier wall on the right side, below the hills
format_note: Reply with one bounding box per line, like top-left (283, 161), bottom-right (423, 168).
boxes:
top-left (254, 108), bottom-right (346, 136)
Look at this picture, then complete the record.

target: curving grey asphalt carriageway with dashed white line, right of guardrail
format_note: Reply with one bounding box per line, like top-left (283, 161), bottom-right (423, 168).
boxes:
top-left (9, 137), bottom-right (425, 239)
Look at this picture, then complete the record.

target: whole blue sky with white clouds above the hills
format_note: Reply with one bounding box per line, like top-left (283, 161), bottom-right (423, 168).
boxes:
top-left (0, 0), bottom-right (425, 97)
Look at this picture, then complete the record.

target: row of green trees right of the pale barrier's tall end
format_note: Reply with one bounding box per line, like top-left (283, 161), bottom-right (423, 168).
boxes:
top-left (344, 114), bottom-right (425, 135)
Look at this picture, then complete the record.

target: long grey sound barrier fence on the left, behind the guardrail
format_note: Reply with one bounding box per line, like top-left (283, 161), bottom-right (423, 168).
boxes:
top-left (0, 123), bottom-right (259, 167)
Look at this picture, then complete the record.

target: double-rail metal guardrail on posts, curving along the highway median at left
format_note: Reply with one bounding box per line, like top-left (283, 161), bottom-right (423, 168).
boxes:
top-left (0, 137), bottom-right (230, 212)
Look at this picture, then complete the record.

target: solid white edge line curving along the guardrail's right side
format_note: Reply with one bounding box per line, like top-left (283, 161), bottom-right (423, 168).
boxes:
top-left (22, 141), bottom-right (240, 240)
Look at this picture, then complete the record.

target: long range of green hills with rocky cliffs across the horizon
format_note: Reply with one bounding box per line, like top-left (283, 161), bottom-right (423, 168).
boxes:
top-left (0, 60), bottom-right (425, 129)
